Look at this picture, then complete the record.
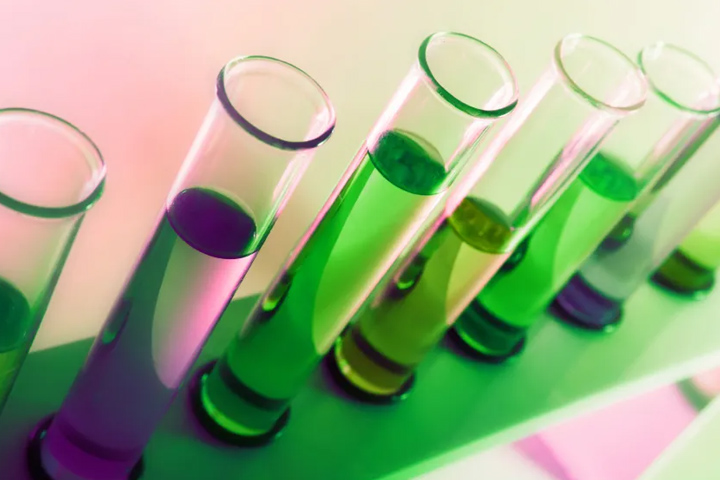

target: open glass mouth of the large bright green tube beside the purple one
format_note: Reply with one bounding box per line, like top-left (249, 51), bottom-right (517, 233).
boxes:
top-left (418, 32), bottom-right (520, 118)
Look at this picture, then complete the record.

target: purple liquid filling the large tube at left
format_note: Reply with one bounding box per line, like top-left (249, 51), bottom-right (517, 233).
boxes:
top-left (42, 188), bottom-right (260, 480)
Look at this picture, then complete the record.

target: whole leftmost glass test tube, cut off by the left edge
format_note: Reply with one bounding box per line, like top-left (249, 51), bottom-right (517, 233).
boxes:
top-left (0, 108), bottom-right (105, 410)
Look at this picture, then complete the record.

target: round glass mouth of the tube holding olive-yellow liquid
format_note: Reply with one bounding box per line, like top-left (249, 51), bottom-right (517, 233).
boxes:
top-left (553, 33), bottom-right (648, 115)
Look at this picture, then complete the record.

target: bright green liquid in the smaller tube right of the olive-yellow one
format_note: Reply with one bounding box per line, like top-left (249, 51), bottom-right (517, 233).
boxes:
top-left (455, 153), bottom-right (638, 356)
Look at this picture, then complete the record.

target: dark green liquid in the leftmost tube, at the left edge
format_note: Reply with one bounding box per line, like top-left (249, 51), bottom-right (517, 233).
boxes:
top-left (0, 278), bottom-right (33, 409)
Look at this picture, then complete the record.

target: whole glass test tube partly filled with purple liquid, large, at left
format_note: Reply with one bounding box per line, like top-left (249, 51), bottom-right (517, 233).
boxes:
top-left (33, 56), bottom-right (335, 480)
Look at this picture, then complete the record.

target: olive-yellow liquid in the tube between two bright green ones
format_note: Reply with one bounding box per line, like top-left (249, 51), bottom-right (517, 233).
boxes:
top-left (335, 197), bottom-right (513, 395)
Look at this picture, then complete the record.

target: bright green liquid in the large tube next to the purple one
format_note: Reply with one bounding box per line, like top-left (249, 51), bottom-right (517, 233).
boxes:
top-left (203, 131), bottom-right (448, 435)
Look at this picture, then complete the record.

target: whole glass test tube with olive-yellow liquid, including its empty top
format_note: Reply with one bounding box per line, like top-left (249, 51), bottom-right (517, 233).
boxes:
top-left (334, 35), bottom-right (646, 399)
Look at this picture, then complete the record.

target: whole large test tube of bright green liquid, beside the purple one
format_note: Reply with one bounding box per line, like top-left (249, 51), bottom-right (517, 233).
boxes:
top-left (192, 32), bottom-right (518, 445)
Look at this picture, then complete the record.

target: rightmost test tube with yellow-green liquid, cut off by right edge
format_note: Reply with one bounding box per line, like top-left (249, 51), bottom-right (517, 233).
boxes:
top-left (653, 196), bottom-right (720, 296)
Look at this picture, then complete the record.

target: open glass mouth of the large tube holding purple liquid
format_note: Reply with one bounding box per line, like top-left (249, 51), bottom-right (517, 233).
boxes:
top-left (217, 55), bottom-right (336, 150)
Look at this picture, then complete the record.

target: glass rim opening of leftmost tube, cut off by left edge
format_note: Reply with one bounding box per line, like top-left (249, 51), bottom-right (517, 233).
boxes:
top-left (0, 108), bottom-right (106, 218)
